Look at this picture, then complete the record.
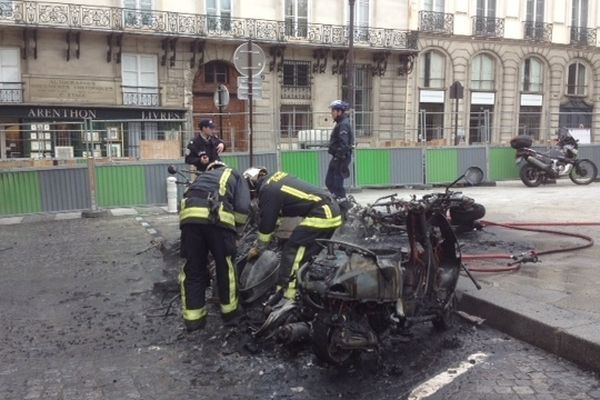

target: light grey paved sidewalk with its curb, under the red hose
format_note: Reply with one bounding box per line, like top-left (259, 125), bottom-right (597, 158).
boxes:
top-left (0, 180), bottom-right (600, 371)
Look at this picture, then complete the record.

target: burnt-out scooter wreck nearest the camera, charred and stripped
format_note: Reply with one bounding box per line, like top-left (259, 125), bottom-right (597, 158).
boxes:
top-left (256, 167), bottom-right (483, 365)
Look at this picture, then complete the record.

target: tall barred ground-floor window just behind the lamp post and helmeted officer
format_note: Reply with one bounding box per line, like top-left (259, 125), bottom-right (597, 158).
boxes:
top-left (342, 65), bottom-right (373, 136)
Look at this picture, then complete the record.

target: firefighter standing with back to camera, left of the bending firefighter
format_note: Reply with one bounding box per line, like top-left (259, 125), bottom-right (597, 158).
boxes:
top-left (179, 161), bottom-right (250, 332)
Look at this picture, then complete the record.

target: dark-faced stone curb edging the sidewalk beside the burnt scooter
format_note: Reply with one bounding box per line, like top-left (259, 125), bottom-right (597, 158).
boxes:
top-left (457, 281), bottom-right (600, 372)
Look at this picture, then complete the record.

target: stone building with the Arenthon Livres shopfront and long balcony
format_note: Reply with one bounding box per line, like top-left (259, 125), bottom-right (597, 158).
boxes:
top-left (0, 0), bottom-right (417, 159)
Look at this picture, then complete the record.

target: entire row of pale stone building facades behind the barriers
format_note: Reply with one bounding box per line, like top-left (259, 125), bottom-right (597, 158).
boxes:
top-left (0, 0), bottom-right (600, 159)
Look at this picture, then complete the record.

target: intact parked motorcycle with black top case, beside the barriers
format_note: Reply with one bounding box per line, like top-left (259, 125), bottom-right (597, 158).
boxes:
top-left (510, 130), bottom-right (598, 187)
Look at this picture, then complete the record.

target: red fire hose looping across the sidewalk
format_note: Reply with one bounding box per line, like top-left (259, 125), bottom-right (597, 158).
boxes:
top-left (462, 221), bottom-right (600, 272)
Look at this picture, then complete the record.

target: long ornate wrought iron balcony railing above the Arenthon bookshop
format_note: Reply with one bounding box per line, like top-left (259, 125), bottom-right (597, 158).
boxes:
top-left (0, 0), bottom-right (417, 50)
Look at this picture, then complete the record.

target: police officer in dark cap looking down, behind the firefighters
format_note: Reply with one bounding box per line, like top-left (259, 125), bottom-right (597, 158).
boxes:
top-left (185, 119), bottom-right (225, 171)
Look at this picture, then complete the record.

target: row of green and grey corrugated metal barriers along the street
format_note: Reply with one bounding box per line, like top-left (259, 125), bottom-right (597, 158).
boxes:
top-left (0, 145), bottom-right (600, 216)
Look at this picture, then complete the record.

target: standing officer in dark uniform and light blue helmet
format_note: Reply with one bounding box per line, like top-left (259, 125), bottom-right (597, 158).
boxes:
top-left (325, 100), bottom-right (354, 202)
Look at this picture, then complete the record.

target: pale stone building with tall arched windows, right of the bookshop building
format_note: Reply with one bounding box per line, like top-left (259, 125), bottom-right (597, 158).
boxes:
top-left (407, 0), bottom-right (600, 144)
